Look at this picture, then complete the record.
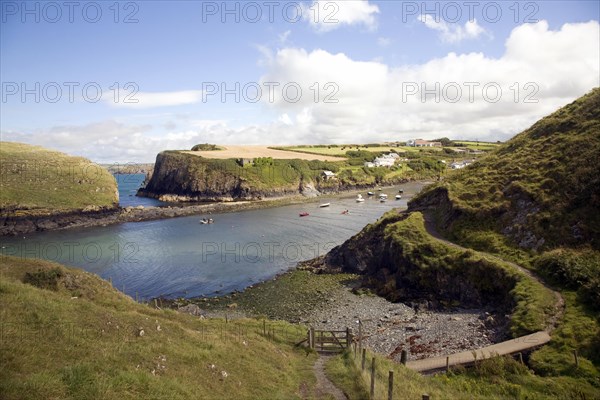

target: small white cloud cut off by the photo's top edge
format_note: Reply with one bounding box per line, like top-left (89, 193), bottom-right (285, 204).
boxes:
top-left (302, 0), bottom-right (379, 32)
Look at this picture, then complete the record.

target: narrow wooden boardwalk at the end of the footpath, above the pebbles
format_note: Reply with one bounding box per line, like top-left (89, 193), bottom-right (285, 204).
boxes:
top-left (406, 331), bottom-right (550, 372)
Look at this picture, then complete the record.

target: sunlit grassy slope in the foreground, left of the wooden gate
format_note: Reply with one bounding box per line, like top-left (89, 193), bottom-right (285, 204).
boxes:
top-left (0, 257), bottom-right (315, 400)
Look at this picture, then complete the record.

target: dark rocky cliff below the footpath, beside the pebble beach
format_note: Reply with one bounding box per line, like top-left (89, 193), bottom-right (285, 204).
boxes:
top-left (324, 211), bottom-right (517, 309)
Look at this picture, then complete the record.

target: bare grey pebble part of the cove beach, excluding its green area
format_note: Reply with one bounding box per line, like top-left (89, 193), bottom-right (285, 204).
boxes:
top-left (306, 282), bottom-right (505, 361)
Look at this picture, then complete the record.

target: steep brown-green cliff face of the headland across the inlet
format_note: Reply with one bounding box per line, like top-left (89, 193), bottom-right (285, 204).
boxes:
top-left (138, 151), bottom-right (390, 201)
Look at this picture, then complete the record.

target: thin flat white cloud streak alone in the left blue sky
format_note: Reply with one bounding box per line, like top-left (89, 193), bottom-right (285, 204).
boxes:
top-left (105, 88), bottom-right (202, 109)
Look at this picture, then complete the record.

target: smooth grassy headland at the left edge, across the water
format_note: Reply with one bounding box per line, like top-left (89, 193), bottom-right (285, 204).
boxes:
top-left (0, 142), bottom-right (119, 215)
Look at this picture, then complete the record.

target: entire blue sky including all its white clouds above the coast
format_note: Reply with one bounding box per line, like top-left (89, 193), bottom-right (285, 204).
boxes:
top-left (0, 0), bottom-right (600, 162)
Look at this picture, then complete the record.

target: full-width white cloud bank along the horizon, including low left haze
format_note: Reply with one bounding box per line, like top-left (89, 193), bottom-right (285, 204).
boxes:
top-left (2, 21), bottom-right (600, 162)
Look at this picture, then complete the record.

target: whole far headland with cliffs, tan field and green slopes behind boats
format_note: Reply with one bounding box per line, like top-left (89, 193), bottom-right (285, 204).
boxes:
top-left (140, 142), bottom-right (476, 201)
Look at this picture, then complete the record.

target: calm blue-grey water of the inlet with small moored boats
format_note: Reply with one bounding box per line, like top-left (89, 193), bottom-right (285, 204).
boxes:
top-left (0, 176), bottom-right (423, 299)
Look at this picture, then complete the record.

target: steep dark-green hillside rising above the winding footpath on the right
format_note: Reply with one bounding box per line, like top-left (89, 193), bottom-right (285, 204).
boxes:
top-left (411, 88), bottom-right (600, 255)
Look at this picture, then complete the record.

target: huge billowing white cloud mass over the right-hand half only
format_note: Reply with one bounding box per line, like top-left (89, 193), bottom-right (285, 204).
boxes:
top-left (261, 21), bottom-right (600, 143)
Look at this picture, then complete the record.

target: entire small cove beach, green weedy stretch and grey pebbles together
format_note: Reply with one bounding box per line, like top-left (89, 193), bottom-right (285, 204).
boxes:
top-left (171, 270), bottom-right (508, 361)
